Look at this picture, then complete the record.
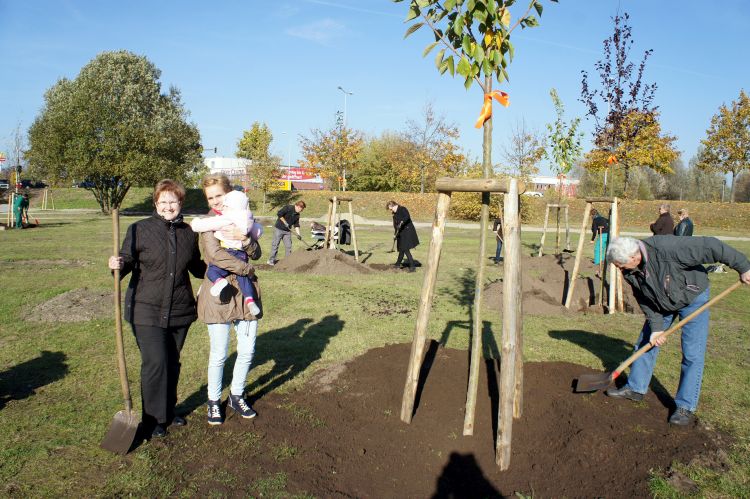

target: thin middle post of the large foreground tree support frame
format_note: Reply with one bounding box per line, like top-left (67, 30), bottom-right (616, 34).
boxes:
top-left (464, 192), bottom-right (490, 435)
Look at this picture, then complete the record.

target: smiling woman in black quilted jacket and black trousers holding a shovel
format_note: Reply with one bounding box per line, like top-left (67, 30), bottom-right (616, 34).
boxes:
top-left (108, 179), bottom-right (206, 437)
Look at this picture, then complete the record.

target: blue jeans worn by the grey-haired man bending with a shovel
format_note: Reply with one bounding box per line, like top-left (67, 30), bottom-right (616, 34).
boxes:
top-left (628, 289), bottom-right (710, 412)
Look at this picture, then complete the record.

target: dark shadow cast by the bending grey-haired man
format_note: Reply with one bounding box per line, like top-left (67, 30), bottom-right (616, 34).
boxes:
top-left (549, 329), bottom-right (675, 411)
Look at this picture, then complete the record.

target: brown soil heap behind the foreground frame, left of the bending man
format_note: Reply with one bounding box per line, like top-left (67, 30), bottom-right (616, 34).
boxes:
top-left (485, 253), bottom-right (640, 315)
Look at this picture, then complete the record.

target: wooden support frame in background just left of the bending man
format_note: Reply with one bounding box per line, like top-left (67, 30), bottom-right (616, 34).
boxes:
top-left (565, 197), bottom-right (624, 314)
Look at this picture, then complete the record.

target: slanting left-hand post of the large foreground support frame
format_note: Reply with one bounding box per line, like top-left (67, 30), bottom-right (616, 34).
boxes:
top-left (401, 192), bottom-right (451, 423)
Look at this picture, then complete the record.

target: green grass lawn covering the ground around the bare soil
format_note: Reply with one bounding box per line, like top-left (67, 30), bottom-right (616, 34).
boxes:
top-left (0, 214), bottom-right (750, 497)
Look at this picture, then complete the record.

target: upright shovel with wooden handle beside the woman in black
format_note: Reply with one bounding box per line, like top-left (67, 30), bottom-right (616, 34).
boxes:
top-left (102, 209), bottom-right (138, 454)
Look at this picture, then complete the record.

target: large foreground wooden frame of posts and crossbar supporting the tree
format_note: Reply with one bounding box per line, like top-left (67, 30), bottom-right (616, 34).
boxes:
top-left (401, 178), bottom-right (523, 470)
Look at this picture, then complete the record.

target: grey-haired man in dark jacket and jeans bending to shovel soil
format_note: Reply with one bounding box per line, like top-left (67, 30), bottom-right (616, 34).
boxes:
top-left (607, 236), bottom-right (750, 426)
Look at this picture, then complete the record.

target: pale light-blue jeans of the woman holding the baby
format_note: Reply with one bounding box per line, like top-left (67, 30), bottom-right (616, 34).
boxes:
top-left (206, 321), bottom-right (258, 401)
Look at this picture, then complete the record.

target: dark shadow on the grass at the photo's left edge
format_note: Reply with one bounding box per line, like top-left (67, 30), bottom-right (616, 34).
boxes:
top-left (0, 350), bottom-right (68, 409)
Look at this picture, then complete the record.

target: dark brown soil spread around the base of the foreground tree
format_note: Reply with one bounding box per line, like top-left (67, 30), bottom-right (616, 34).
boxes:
top-left (163, 343), bottom-right (728, 498)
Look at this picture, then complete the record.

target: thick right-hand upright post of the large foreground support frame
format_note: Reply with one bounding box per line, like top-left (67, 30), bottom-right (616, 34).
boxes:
top-left (495, 179), bottom-right (523, 470)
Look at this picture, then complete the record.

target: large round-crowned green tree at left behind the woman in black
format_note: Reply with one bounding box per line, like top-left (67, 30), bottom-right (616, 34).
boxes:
top-left (26, 51), bottom-right (201, 213)
